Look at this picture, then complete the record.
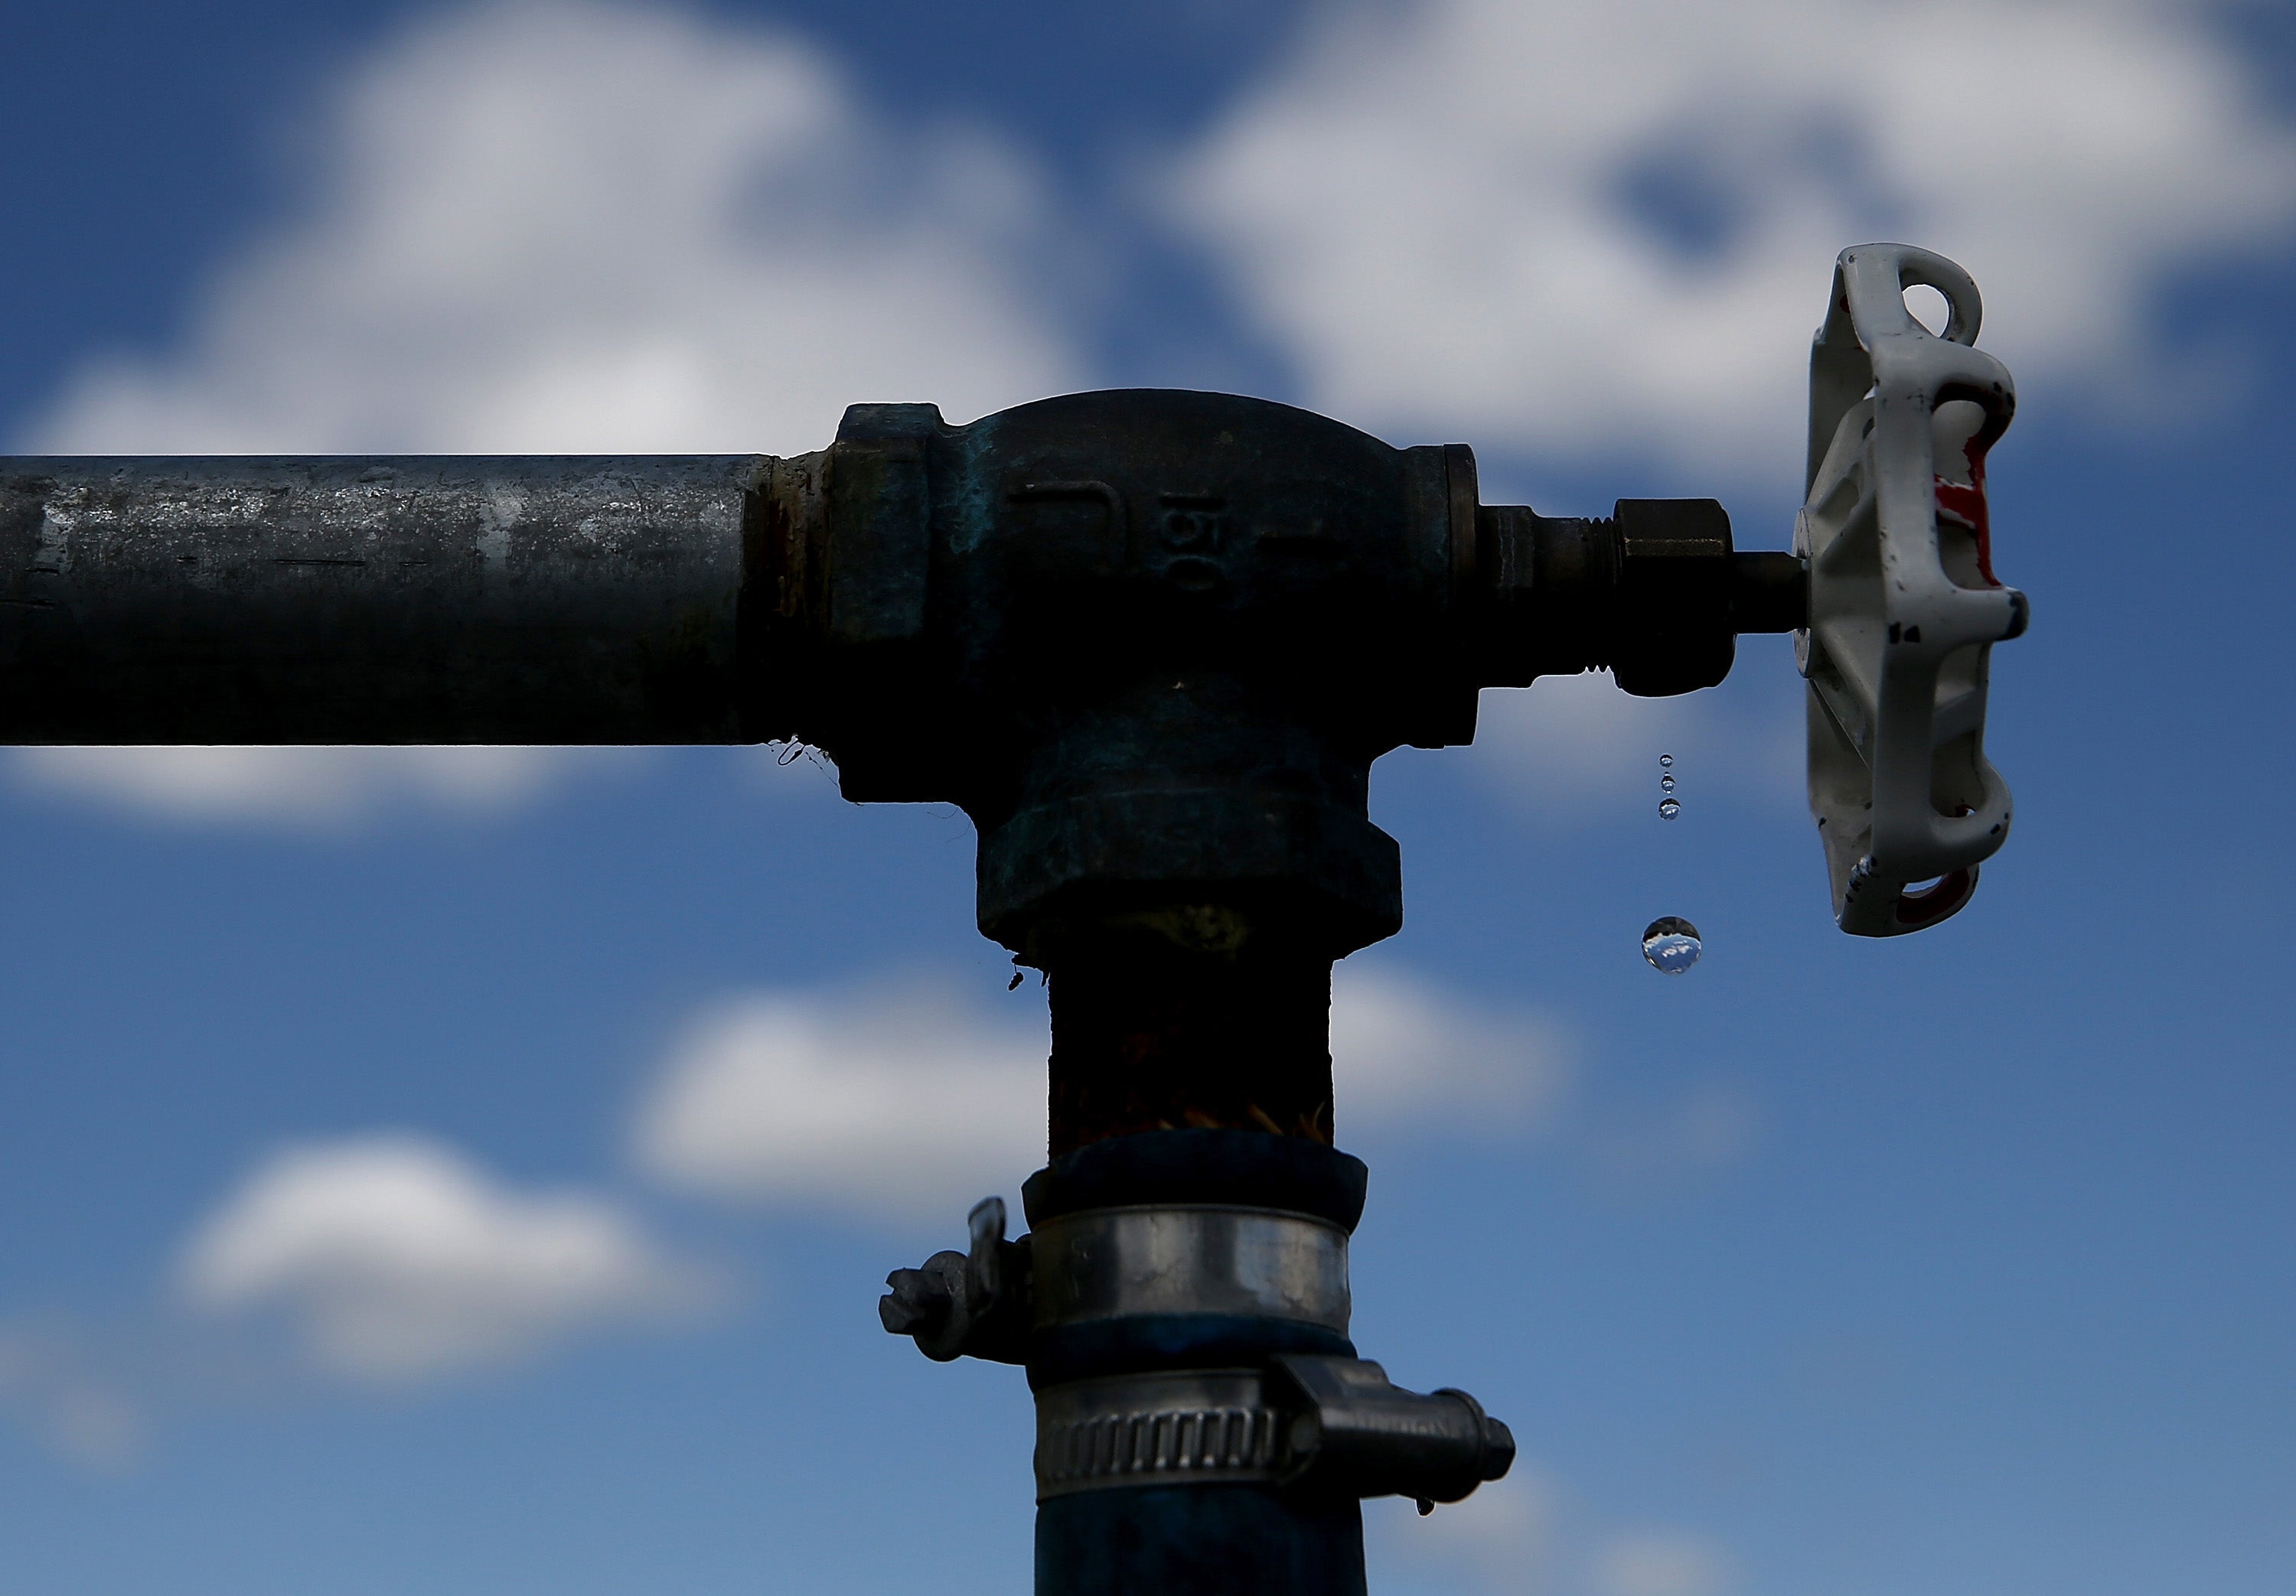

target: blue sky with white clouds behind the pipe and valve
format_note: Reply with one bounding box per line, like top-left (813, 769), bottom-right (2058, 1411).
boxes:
top-left (0, 0), bottom-right (2296, 1596)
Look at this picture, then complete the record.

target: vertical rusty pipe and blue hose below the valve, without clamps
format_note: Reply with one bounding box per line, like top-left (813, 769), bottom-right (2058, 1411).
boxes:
top-left (1026, 907), bottom-right (1364, 1596)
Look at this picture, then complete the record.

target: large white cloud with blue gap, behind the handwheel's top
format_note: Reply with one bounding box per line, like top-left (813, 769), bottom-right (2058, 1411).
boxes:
top-left (1173, 0), bottom-right (2296, 487)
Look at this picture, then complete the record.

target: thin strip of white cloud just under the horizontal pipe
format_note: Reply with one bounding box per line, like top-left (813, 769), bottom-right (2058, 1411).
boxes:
top-left (11, 746), bottom-right (638, 829)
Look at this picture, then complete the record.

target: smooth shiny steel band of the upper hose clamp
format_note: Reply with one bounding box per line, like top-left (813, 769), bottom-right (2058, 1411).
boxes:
top-left (1031, 1206), bottom-right (1348, 1334)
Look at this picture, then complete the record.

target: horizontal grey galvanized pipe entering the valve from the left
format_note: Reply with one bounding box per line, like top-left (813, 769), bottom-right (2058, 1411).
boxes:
top-left (0, 454), bottom-right (776, 744)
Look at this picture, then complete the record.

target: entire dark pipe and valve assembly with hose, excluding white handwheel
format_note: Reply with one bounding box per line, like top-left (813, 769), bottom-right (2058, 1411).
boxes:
top-left (18, 390), bottom-right (1754, 1596)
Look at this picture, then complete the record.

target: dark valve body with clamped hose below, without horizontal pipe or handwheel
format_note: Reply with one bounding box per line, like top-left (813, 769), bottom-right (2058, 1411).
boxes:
top-left (827, 392), bottom-right (1773, 1596)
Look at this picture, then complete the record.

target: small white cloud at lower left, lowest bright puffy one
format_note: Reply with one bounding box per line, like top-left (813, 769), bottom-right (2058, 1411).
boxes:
top-left (179, 1135), bottom-right (709, 1383)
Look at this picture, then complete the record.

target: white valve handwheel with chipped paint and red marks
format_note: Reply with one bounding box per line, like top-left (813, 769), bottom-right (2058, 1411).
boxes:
top-left (1793, 243), bottom-right (2027, 937)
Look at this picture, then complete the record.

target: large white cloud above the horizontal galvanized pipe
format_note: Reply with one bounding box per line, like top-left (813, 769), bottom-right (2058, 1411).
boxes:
top-left (32, 0), bottom-right (1077, 452)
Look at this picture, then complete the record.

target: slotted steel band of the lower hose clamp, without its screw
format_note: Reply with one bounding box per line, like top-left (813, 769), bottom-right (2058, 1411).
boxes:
top-left (1035, 1369), bottom-right (1290, 1502)
